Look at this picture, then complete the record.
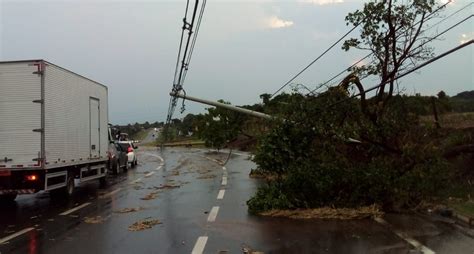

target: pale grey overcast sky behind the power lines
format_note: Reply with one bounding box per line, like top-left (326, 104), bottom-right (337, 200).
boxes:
top-left (0, 0), bottom-right (474, 124)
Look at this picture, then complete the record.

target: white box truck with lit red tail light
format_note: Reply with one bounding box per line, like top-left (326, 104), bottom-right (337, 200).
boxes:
top-left (0, 60), bottom-right (109, 200)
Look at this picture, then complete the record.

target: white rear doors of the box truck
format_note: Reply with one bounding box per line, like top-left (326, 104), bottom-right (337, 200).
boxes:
top-left (0, 61), bottom-right (43, 170)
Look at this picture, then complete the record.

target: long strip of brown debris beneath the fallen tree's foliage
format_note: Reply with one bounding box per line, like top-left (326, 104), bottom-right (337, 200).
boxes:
top-left (260, 205), bottom-right (383, 220)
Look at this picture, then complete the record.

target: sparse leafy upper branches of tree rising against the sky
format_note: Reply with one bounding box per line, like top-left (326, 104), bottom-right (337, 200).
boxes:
top-left (342, 0), bottom-right (438, 79)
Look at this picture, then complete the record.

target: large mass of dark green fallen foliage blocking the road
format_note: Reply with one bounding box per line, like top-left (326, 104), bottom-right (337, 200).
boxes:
top-left (248, 90), bottom-right (450, 212)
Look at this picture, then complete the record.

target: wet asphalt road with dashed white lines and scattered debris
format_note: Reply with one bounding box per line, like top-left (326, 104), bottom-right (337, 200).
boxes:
top-left (0, 147), bottom-right (474, 254)
